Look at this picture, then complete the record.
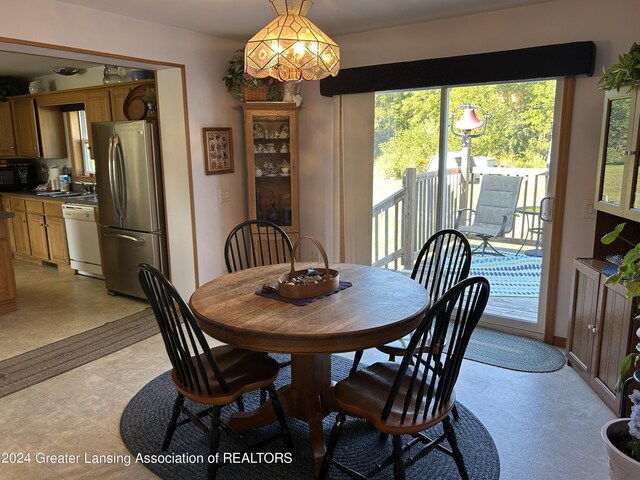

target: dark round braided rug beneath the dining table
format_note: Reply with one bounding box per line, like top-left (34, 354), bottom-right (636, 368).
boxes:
top-left (120, 355), bottom-right (500, 480)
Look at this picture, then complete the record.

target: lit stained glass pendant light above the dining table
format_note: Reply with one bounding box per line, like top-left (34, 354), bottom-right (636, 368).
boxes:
top-left (244, 0), bottom-right (340, 82)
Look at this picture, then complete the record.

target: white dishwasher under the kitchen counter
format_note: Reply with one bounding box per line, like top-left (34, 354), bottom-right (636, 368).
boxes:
top-left (62, 203), bottom-right (104, 278)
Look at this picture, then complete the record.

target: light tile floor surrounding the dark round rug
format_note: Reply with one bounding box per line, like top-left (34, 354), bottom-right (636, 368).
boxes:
top-left (0, 264), bottom-right (614, 480)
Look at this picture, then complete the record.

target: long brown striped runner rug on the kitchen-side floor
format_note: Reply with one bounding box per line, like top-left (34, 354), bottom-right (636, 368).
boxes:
top-left (0, 308), bottom-right (159, 398)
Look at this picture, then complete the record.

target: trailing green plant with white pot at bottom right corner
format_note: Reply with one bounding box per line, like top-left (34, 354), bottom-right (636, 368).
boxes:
top-left (601, 223), bottom-right (640, 479)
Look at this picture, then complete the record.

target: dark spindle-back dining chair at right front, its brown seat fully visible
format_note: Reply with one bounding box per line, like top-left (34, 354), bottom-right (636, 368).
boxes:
top-left (319, 277), bottom-right (490, 480)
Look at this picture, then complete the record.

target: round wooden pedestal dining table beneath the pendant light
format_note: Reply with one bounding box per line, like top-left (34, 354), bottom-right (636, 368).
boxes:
top-left (189, 263), bottom-right (430, 473)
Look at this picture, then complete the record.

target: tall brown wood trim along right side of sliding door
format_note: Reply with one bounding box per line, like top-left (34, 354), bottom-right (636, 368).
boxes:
top-left (544, 77), bottom-right (576, 345)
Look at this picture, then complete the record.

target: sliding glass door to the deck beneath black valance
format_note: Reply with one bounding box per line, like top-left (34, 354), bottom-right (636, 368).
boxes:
top-left (372, 80), bottom-right (556, 335)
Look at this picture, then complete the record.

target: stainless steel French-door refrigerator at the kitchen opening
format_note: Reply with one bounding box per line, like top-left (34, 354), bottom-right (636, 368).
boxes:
top-left (91, 120), bottom-right (167, 298)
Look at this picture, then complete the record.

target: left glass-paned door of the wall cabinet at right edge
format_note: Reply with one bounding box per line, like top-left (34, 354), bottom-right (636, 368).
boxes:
top-left (599, 96), bottom-right (631, 206)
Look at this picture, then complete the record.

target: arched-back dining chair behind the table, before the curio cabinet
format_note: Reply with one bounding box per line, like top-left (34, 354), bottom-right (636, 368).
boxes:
top-left (224, 220), bottom-right (293, 403)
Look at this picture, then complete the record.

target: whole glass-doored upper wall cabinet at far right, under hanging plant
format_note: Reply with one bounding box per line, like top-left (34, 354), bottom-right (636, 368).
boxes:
top-left (596, 88), bottom-right (640, 221)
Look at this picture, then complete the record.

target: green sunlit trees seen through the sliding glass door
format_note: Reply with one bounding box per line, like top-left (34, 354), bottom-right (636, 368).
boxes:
top-left (374, 80), bottom-right (556, 178)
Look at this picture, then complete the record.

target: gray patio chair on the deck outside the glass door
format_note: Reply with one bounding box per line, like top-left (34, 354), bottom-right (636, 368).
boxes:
top-left (455, 175), bottom-right (522, 255)
